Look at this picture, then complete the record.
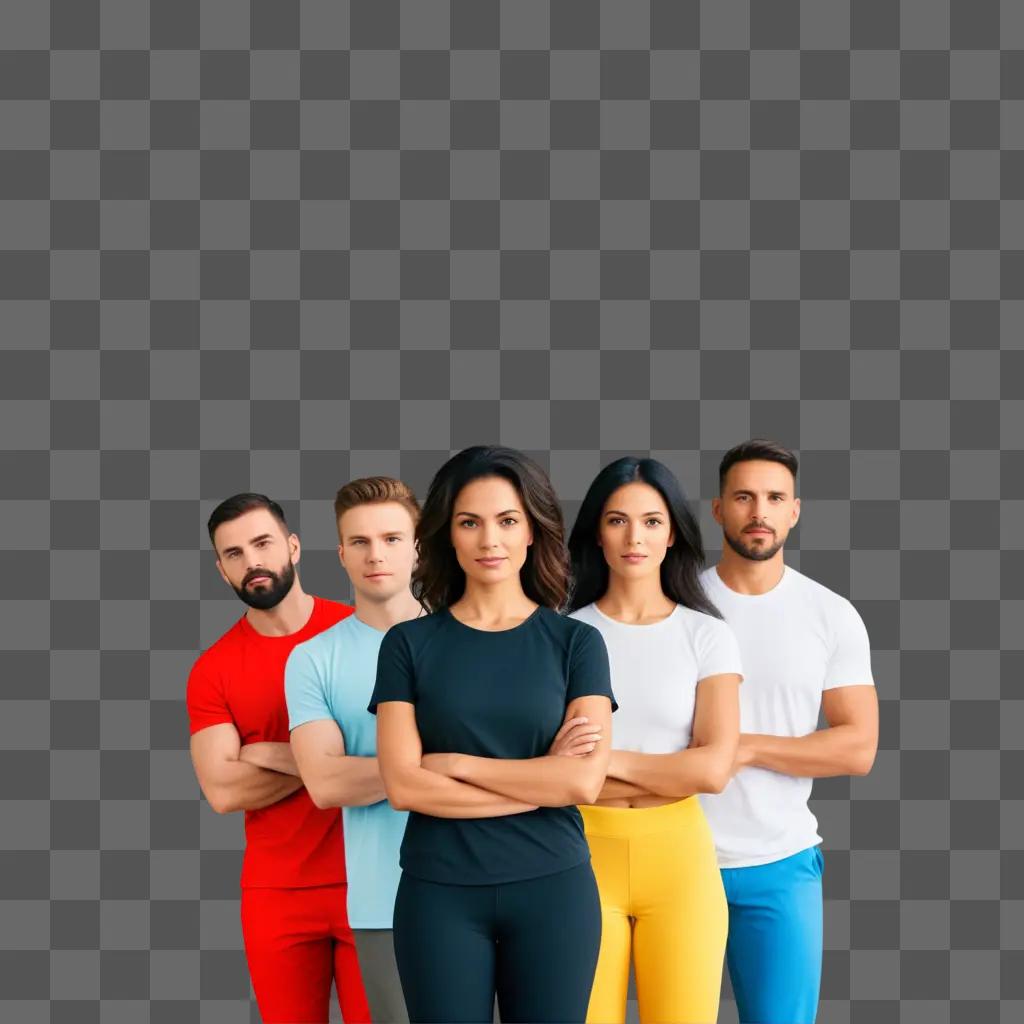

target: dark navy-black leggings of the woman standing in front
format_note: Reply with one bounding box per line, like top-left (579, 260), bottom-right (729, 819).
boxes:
top-left (394, 861), bottom-right (601, 1024)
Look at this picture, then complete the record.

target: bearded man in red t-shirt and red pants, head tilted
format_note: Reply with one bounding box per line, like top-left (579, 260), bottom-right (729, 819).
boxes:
top-left (187, 494), bottom-right (370, 1024)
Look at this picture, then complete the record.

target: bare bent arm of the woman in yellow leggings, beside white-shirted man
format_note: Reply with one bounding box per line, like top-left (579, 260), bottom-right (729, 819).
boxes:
top-left (608, 673), bottom-right (739, 800)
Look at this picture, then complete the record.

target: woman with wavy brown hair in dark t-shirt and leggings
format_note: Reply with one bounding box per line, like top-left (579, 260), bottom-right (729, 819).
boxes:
top-left (370, 446), bottom-right (614, 1024)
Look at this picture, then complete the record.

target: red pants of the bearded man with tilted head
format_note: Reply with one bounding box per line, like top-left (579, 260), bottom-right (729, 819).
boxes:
top-left (242, 884), bottom-right (370, 1024)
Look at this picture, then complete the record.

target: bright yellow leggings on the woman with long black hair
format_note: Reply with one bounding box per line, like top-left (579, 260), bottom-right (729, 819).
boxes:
top-left (580, 797), bottom-right (729, 1024)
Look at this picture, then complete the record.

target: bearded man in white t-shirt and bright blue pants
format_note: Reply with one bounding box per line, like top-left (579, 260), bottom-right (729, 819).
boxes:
top-left (700, 439), bottom-right (879, 1024)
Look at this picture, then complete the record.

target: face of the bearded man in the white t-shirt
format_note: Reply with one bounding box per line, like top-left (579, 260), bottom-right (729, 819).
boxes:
top-left (712, 459), bottom-right (800, 562)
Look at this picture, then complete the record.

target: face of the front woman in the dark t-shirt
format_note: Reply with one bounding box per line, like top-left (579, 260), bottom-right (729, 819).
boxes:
top-left (452, 476), bottom-right (534, 586)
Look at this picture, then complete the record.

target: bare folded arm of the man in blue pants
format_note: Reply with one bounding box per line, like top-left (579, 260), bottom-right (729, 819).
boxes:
top-left (736, 685), bottom-right (879, 778)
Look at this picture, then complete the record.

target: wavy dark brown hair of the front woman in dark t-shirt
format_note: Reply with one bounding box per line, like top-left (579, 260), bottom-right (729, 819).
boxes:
top-left (413, 444), bottom-right (569, 611)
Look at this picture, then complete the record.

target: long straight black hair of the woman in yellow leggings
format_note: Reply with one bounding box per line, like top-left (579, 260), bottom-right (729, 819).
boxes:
top-left (568, 456), bottom-right (722, 618)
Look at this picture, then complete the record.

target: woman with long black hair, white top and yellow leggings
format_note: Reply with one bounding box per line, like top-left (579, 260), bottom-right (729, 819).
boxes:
top-left (569, 458), bottom-right (741, 1024)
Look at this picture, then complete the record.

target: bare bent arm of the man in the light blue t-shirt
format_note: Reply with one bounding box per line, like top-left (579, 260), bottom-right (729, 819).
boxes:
top-left (292, 719), bottom-right (385, 808)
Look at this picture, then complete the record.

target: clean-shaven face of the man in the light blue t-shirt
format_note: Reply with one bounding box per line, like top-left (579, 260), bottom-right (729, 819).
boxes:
top-left (338, 502), bottom-right (416, 602)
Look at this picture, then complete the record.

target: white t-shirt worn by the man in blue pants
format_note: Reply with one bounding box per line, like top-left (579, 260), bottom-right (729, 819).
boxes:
top-left (700, 566), bottom-right (874, 867)
